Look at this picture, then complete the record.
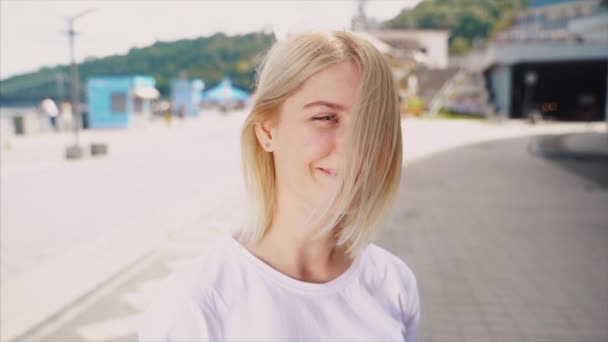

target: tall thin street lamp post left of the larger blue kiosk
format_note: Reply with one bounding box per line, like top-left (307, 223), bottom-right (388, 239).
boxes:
top-left (66, 8), bottom-right (95, 159)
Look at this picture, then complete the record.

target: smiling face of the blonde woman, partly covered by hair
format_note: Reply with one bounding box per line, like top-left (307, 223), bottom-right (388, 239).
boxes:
top-left (256, 62), bottom-right (359, 211)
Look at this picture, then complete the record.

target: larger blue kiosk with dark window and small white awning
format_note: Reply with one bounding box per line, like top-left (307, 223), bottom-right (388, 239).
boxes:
top-left (87, 76), bottom-right (160, 128)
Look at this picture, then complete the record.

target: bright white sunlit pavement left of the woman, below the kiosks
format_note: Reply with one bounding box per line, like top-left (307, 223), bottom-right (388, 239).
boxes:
top-left (0, 111), bottom-right (244, 341)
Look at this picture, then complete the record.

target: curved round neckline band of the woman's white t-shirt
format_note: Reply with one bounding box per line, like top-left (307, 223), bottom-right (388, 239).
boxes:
top-left (229, 235), bottom-right (360, 294)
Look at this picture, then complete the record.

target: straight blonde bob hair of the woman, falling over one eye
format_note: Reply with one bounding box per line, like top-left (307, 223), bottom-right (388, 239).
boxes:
top-left (237, 31), bottom-right (402, 256)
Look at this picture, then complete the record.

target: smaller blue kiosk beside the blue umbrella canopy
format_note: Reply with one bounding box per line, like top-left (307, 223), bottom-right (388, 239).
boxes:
top-left (171, 79), bottom-right (205, 116)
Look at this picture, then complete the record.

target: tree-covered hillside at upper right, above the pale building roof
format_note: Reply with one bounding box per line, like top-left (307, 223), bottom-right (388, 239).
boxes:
top-left (383, 0), bottom-right (527, 53)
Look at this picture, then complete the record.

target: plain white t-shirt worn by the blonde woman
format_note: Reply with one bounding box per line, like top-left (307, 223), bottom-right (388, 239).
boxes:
top-left (139, 235), bottom-right (420, 342)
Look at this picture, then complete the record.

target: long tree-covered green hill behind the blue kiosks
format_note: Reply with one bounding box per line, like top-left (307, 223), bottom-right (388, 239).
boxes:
top-left (0, 33), bottom-right (274, 105)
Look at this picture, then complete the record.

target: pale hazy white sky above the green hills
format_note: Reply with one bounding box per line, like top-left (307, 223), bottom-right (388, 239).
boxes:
top-left (0, 0), bottom-right (421, 79)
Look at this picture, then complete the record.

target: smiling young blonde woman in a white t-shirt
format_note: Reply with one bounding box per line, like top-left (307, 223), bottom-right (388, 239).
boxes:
top-left (139, 32), bottom-right (420, 342)
